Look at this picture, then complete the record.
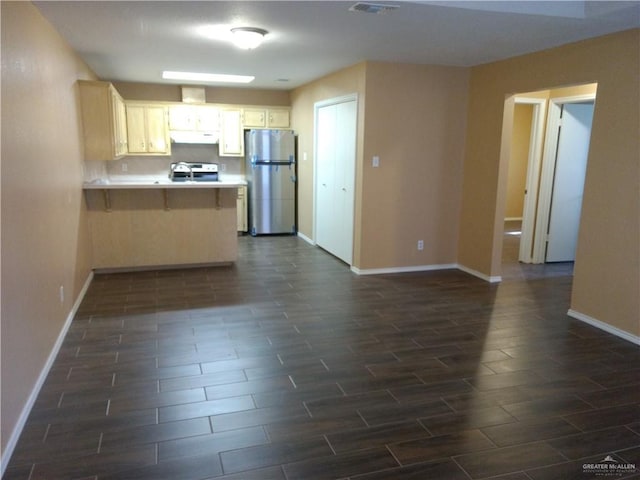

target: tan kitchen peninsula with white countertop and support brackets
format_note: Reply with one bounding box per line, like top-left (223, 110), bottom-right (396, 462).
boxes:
top-left (83, 176), bottom-right (245, 271)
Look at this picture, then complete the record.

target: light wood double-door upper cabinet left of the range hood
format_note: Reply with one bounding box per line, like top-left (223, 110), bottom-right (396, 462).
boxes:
top-left (125, 102), bottom-right (171, 155)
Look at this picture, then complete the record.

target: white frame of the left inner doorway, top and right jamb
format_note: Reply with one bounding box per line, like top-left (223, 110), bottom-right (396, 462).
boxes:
top-left (514, 95), bottom-right (548, 263)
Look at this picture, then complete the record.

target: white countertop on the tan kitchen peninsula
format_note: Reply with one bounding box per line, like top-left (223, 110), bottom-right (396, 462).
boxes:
top-left (82, 175), bottom-right (247, 190)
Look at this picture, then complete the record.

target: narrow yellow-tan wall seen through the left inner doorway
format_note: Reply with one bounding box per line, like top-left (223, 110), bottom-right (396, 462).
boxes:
top-left (504, 104), bottom-right (533, 218)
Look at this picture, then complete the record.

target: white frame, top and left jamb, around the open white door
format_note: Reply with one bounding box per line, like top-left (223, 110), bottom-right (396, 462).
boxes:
top-left (532, 93), bottom-right (596, 263)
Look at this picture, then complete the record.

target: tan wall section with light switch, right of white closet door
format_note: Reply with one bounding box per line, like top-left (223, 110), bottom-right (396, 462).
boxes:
top-left (358, 62), bottom-right (469, 269)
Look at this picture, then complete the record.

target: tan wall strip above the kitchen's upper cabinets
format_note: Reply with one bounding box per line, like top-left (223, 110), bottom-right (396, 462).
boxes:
top-left (112, 81), bottom-right (291, 107)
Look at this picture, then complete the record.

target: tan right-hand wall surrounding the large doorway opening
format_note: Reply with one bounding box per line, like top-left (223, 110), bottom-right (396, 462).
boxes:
top-left (458, 29), bottom-right (640, 335)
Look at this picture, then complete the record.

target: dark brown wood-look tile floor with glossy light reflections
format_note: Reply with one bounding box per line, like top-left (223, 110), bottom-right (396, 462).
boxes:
top-left (5, 237), bottom-right (640, 480)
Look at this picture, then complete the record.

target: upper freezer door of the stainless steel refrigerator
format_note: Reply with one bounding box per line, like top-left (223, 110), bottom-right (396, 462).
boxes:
top-left (245, 130), bottom-right (295, 164)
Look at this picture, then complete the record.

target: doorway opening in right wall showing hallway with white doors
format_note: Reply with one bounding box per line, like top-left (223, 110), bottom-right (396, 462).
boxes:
top-left (502, 84), bottom-right (597, 277)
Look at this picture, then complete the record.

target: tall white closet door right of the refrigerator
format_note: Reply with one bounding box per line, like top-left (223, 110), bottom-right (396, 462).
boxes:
top-left (315, 96), bottom-right (357, 265)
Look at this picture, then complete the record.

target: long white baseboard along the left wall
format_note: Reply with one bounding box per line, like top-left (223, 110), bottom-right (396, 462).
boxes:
top-left (0, 272), bottom-right (93, 477)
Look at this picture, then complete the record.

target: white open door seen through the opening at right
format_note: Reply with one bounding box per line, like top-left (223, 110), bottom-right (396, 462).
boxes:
top-left (545, 103), bottom-right (594, 262)
